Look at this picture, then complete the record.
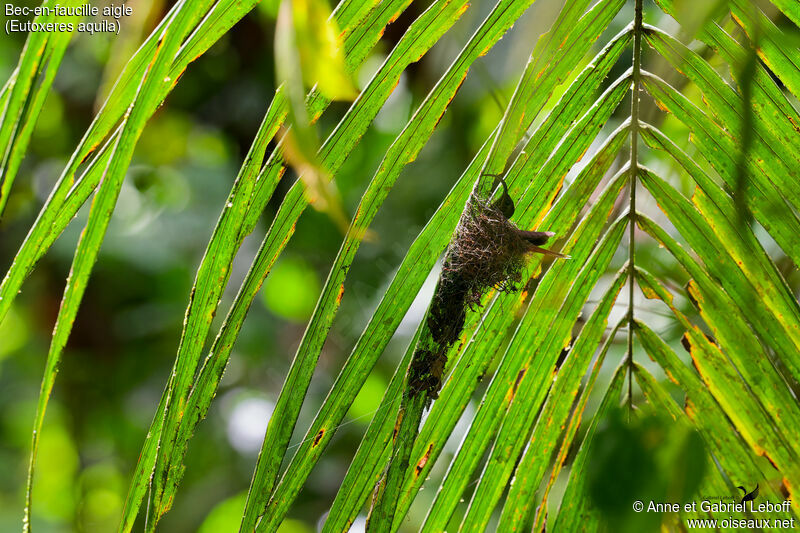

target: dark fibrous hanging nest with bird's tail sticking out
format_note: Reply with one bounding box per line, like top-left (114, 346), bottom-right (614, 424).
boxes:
top-left (409, 193), bottom-right (565, 398)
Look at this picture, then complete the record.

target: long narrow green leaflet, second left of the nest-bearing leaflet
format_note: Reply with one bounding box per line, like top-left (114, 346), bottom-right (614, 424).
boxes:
top-left (242, 3), bottom-right (526, 530)
